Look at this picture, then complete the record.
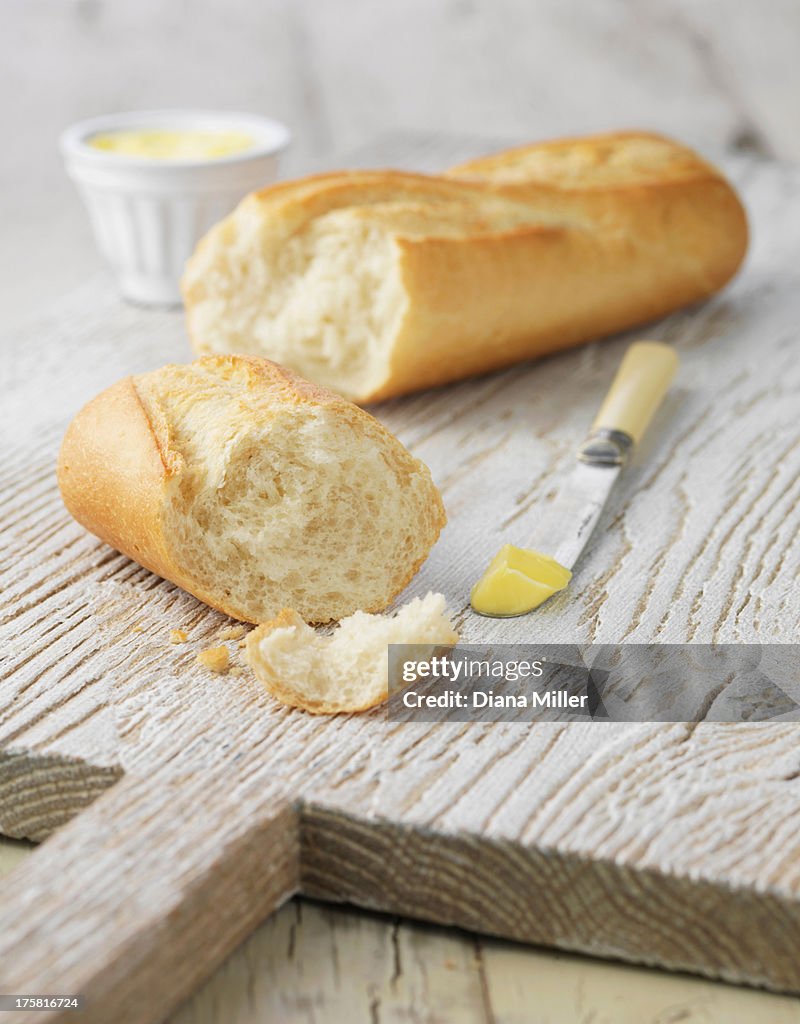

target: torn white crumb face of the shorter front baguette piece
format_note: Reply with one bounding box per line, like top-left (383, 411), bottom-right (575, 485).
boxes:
top-left (137, 358), bottom-right (441, 623)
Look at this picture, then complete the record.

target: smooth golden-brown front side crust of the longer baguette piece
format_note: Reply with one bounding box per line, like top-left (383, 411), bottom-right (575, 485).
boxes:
top-left (364, 178), bottom-right (747, 401)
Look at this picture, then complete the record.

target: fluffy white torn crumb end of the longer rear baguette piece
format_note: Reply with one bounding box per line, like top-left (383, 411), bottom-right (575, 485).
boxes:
top-left (186, 211), bottom-right (406, 396)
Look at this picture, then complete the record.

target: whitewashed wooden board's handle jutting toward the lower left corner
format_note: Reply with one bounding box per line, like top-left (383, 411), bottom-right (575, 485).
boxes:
top-left (0, 761), bottom-right (297, 1024)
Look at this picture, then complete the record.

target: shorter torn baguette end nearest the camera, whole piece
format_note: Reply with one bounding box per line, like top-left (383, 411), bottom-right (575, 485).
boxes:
top-left (58, 356), bottom-right (445, 623)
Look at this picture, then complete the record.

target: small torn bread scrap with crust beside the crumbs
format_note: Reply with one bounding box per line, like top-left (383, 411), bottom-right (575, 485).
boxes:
top-left (247, 594), bottom-right (458, 715)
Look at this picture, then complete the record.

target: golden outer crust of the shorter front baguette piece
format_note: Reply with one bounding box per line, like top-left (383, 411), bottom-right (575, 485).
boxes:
top-left (57, 355), bottom-right (447, 623)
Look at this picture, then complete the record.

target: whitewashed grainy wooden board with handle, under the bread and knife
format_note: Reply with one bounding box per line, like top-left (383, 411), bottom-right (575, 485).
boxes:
top-left (0, 138), bottom-right (800, 1021)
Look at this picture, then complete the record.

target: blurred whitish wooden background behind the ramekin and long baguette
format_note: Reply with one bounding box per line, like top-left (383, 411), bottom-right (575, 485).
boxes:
top-left (0, 0), bottom-right (800, 323)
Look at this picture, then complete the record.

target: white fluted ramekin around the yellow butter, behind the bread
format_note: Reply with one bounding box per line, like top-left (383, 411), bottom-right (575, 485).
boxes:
top-left (60, 111), bottom-right (289, 305)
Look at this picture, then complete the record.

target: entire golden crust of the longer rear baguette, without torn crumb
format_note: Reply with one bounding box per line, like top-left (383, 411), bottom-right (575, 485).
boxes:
top-left (184, 132), bottom-right (748, 402)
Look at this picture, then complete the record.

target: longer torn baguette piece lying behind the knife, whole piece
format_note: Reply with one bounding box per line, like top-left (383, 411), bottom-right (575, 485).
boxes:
top-left (183, 132), bottom-right (747, 402)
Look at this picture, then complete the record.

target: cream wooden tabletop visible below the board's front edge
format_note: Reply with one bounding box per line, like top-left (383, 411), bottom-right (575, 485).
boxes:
top-left (0, 837), bottom-right (800, 1024)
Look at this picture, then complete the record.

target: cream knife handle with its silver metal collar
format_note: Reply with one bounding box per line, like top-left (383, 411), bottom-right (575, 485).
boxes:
top-left (580, 341), bottom-right (678, 465)
